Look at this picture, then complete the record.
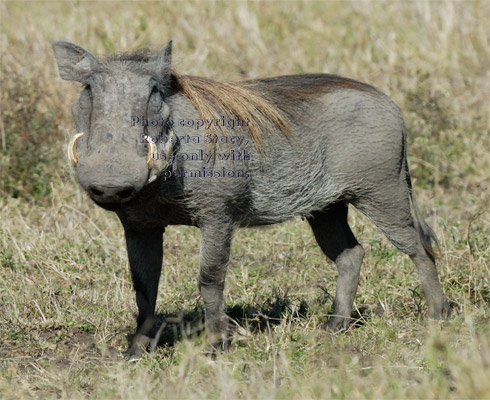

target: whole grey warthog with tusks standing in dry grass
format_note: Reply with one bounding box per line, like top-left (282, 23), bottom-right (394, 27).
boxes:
top-left (53, 42), bottom-right (450, 358)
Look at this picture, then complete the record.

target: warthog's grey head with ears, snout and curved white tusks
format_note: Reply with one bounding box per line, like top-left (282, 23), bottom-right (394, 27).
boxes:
top-left (53, 42), bottom-right (173, 209)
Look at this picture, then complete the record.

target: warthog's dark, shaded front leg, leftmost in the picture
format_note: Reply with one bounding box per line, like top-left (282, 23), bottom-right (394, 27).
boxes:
top-left (125, 229), bottom-right (164, 361)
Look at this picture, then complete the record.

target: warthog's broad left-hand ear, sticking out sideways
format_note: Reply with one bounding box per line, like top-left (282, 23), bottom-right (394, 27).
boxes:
top-left (53, 42), bottom-right (99, 83)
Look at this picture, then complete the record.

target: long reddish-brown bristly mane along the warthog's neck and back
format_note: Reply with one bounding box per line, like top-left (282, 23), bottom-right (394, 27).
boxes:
top-left (174, 73), bottom-right (382, 152)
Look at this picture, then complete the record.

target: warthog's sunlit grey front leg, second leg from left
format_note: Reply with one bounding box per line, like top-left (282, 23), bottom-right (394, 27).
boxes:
top-left (199, 222), bottom-right (233, 352)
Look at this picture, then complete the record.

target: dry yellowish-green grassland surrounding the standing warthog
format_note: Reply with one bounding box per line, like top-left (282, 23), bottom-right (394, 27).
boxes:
top-left (0, 1), bottom-right (490, 399)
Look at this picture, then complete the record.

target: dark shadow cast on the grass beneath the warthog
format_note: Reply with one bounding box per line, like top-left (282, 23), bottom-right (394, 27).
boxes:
top-left (128, 288), bottom-right (370, 351)
